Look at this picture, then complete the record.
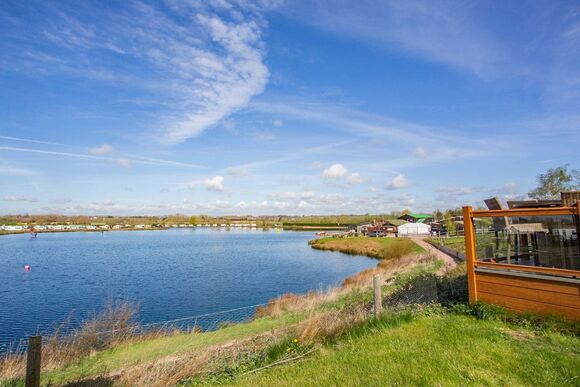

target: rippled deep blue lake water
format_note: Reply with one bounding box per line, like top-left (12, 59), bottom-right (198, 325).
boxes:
top-left (0, 229), bottom-right (376, 350)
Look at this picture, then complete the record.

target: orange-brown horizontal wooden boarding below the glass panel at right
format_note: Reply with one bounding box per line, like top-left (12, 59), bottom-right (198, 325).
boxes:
top-left (475, 272), bottom-right (580, 320)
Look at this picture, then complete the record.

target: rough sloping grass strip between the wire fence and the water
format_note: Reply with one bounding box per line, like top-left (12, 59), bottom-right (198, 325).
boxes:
top-left (0, 247), bottom-right (439, 386)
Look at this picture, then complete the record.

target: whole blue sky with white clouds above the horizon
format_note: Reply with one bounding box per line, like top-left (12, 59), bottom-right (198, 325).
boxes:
top-left (0, 0), bottom-right (580, 215)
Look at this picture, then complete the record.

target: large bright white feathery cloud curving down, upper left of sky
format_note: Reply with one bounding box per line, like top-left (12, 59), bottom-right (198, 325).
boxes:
top-left (159, 14), bottom-right (270, 144)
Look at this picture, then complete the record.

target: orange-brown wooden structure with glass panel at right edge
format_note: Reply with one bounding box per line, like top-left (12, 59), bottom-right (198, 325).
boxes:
top-left (463, 195), bottom-right (580, 320)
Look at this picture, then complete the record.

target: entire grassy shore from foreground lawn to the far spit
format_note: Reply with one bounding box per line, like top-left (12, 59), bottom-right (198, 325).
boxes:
top-left (0, 238), bottom-right (580, 386)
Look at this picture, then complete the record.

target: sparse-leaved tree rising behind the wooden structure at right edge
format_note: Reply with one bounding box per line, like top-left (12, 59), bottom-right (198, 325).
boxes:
top-left (528, 165), bottom-right (580, 199)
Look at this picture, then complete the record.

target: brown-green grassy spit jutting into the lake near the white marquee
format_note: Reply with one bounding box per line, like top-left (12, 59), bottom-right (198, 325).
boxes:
top-left (309, 237), bottom-right (424, 259)
